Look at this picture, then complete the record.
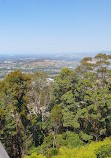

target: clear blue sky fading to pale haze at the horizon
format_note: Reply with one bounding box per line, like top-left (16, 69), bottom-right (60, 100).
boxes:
top-left (0, 0), bottom-right (111, 54)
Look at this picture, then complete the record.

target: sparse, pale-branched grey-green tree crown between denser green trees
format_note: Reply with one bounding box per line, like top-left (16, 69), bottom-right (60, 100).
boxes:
top-left (28, 72), bottom-right (52, 120)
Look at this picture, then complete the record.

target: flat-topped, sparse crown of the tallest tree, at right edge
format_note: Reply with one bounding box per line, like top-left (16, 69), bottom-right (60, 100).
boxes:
top-left (75, 53), bottom-right (111, 87)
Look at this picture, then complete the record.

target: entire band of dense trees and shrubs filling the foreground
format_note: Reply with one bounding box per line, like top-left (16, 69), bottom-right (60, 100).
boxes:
top-left (0, 54), bottom-right (111, 158)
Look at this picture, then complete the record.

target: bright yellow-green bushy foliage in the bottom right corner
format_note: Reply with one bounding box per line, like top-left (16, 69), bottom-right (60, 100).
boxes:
top-left (53, 138), bottom-right (111, 158)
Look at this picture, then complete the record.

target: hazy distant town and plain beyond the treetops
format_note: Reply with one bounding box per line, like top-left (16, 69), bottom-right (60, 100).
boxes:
top-left (0, 55), bottom-right (81, 80)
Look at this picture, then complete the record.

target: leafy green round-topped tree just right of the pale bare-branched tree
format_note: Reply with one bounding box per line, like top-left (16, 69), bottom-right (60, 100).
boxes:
top-left (53, 68), bottom-right (79, 129)
